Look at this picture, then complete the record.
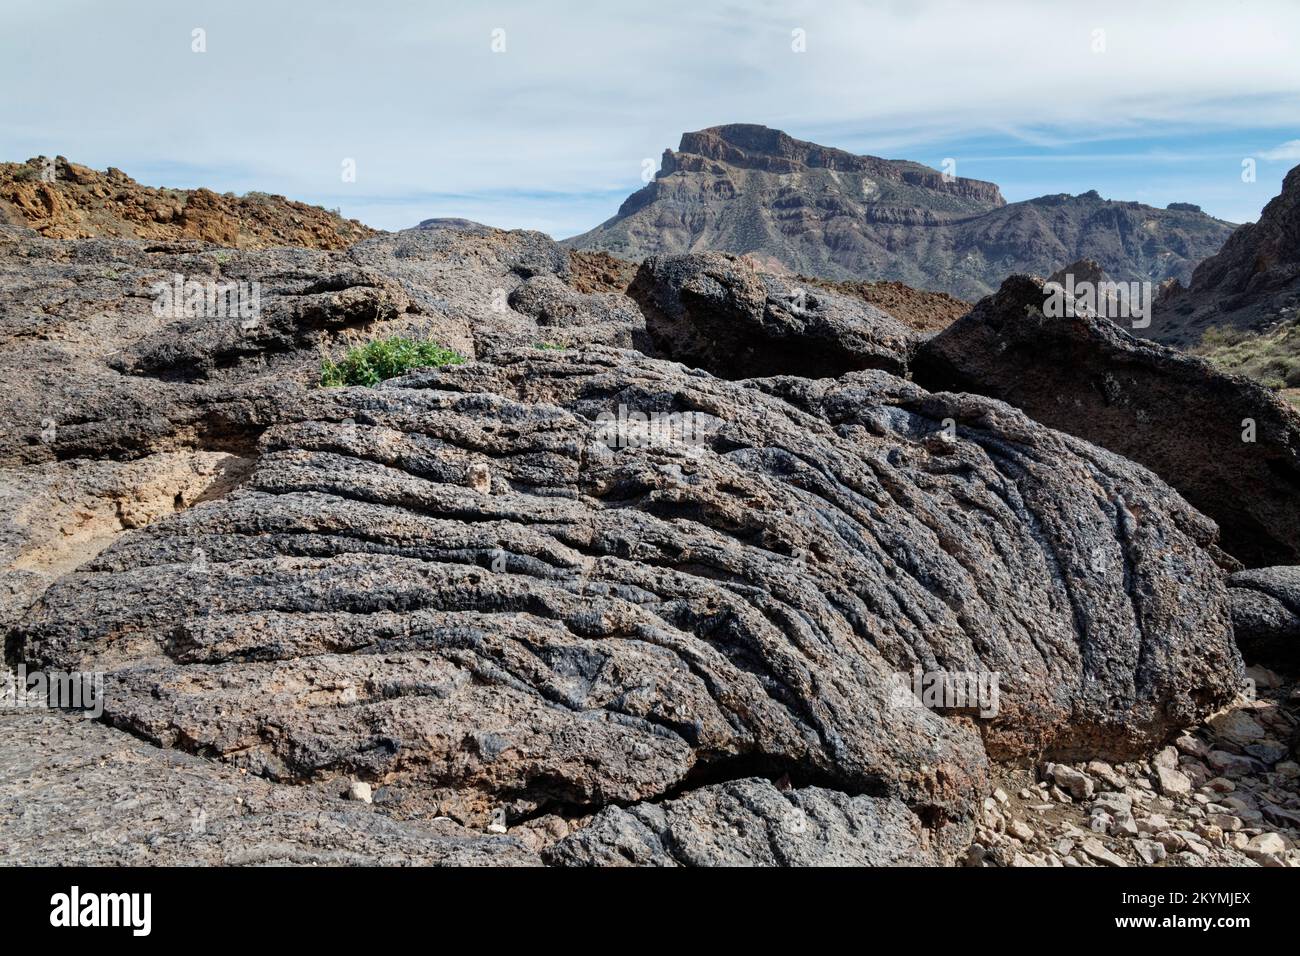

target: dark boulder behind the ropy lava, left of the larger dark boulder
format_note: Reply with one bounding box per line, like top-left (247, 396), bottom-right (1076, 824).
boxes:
top-left (629, 252), bottom-right (915, 378)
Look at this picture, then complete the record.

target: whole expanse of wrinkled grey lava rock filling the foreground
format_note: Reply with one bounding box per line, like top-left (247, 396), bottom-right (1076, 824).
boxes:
top-left (0, 217), bottom-right (1258, 864)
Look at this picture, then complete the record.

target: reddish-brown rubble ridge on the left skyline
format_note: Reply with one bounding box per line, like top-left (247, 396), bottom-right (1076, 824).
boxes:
top-left (0, 156), bottom-right (376, 248)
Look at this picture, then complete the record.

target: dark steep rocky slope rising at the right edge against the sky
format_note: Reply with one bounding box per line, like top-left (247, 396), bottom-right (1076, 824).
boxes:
top-left (1147, 166), bottom-right (1300, 345)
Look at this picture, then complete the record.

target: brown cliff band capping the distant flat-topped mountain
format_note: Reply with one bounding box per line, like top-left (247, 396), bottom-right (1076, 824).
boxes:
top-left (659, 122), bottom-right (1006, 208)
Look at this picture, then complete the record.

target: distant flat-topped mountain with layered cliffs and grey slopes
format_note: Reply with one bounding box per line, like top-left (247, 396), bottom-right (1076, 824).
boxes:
top-left (564, 124), bottom-right (1232, 299)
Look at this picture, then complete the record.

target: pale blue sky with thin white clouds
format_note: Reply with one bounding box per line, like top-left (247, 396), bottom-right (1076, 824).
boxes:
top-left (0, 0), bottom-right (1300, 238)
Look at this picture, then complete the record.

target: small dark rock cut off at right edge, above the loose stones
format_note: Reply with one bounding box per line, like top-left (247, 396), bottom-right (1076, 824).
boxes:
top-left (1229, 566), bottom-right (1300, 672)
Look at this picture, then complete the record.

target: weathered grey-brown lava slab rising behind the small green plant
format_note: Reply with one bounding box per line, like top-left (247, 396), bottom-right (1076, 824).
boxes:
top-left (0, 221), bottom-right (624, 463)
